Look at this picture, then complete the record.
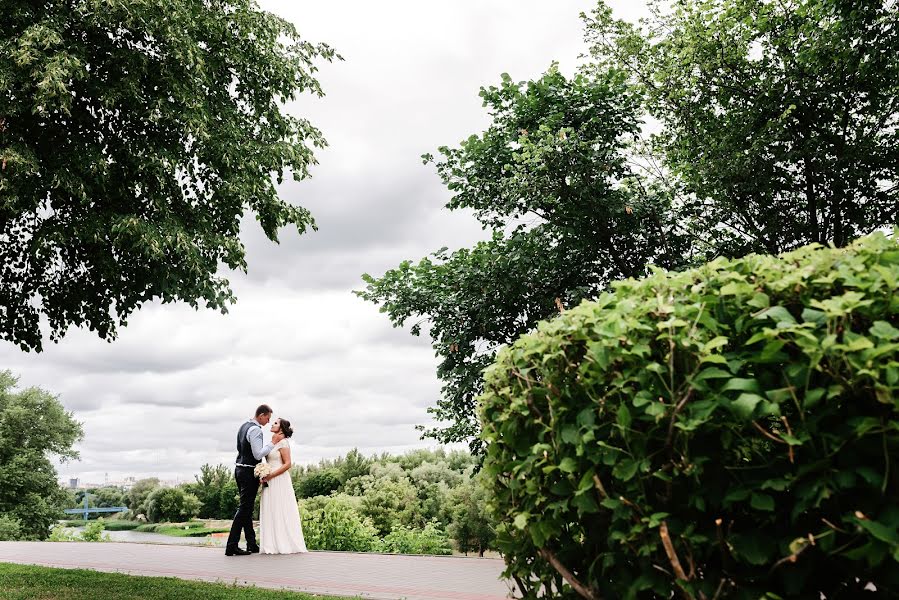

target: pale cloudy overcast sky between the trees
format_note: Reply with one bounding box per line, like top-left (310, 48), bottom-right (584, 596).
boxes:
top-left (0, 0), bottom-right (645, 483)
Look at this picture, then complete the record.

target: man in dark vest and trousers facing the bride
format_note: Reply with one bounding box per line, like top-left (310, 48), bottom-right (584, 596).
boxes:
top-left (225, 404), bottom-right (273, 556)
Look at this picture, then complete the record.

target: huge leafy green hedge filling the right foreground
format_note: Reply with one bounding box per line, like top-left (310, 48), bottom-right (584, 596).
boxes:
top-left (481, 231), bottom-right (899, 599)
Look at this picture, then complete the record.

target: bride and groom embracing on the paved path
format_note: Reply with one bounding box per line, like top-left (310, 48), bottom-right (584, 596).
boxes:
top-left (225, 404), bottom-right (307, 556)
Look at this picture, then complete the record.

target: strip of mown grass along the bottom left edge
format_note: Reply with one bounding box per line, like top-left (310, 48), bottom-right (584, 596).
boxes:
top-left (0, 563), bottom-right (358, 600)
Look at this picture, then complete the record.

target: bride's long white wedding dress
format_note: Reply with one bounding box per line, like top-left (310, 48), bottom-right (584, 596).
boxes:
top-left (259, 440), bottom-right (307, 554)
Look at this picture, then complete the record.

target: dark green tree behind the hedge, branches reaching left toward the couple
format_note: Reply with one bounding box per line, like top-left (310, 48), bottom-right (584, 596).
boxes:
top-left (357, 67), bottom-right (686, 449)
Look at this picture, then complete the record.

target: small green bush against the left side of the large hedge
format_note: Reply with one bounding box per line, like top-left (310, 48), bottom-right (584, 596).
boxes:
top-left (447, 476), bottom-right (496, 556)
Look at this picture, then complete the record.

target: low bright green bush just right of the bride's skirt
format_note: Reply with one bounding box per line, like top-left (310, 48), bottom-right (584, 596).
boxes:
top-left (300, 495), bottom-right (379, 552)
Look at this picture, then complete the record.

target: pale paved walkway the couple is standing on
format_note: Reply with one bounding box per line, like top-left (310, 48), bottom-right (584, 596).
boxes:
top-left (0, 542), bottom-right (510, 600)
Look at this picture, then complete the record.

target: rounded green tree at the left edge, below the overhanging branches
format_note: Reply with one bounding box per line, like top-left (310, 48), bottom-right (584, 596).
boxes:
top-left (0, 371), bottom-right (83, 539)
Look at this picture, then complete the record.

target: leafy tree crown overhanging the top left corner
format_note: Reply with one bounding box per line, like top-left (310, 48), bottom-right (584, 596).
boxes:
top-left (0, 0), bottom-right (335, 350)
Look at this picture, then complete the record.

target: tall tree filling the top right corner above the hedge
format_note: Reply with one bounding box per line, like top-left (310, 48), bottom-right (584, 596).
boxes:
top-left (587, 0), bottom-right (899, 256)
